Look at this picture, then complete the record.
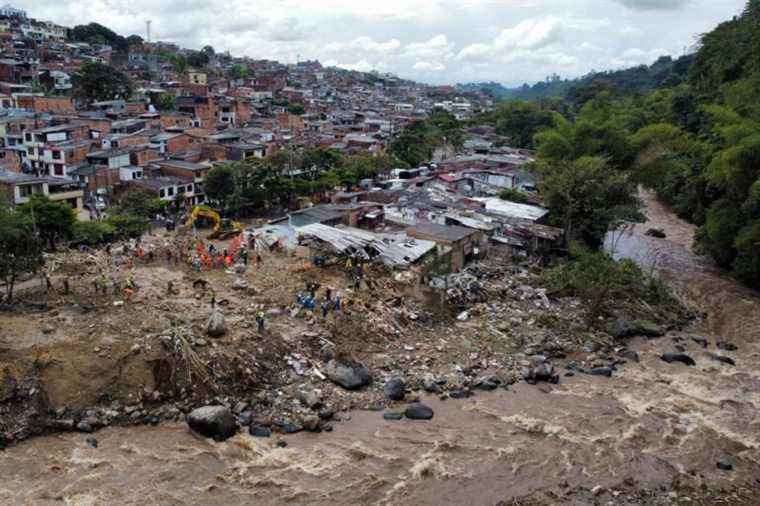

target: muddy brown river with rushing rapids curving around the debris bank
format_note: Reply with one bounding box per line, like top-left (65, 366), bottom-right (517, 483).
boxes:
top-left (0, 191), bottom-right (760, 506)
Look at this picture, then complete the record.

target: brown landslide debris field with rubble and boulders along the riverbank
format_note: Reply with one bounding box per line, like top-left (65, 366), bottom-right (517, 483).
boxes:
top-left (0, 225), bottom-right (683, 443)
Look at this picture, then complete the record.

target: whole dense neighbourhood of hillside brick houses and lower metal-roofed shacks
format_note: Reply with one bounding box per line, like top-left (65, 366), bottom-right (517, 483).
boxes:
top-left (0, 6), bottom-right (559, 270)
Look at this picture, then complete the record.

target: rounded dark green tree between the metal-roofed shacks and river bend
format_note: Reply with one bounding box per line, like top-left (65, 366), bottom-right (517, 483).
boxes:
top-left (539, 157), bottom-right (643, 248)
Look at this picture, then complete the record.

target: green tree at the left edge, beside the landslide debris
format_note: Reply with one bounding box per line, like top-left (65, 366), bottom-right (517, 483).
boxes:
top-left (0, 209), bottom-right (44, 303)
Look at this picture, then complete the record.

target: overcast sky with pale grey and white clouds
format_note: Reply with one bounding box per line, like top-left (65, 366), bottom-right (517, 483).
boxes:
top-left (20, 0), bottom-right (745, 85)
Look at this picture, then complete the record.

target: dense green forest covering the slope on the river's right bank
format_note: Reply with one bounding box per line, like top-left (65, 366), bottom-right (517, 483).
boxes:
top-left (512, 0), bottom-right (760, 288)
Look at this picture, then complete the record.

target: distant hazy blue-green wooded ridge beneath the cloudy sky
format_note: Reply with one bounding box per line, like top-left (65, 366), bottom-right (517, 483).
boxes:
top-left (457, 55), bottom-right (694, 100)
